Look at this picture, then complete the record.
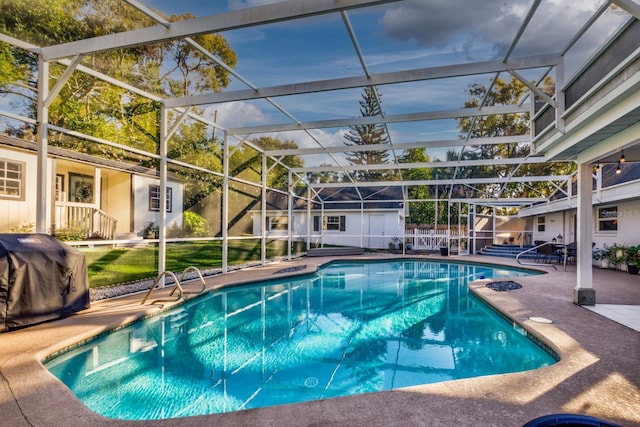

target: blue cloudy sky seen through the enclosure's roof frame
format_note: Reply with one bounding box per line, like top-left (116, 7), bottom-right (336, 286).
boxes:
top-left (0, 0), bottom-right (628, 164)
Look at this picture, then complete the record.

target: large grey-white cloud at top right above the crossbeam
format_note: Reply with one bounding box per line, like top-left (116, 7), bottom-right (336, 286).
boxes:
top-left (381, 0), bottom-right (606, 58)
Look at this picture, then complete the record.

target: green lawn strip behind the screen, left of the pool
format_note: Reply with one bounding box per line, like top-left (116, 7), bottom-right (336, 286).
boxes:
top-left (82, 239), bottom-right (304, 288)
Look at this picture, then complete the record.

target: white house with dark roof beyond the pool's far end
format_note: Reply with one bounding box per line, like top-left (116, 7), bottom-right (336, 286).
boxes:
top-left (252, 187), bottom-right (405, 249)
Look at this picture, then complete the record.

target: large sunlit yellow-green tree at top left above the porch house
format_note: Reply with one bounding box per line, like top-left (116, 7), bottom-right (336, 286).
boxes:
top-left (0, 0), bottom-right (237, 152)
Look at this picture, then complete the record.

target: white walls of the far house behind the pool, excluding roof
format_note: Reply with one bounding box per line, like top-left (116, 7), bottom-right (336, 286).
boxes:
top-left (252, 210), bottom-right (404, 249)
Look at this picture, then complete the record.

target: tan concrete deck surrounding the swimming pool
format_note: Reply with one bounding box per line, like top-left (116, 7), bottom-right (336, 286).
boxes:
top-left (0, 255), bottom-right (640, 427)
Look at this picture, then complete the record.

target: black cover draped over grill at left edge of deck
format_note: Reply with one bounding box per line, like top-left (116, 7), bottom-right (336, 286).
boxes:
top-left (0, 234), bottom-right (89, 329)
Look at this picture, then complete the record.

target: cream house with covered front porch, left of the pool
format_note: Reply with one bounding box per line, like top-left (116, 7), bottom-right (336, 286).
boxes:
top-left (0, 134), bottom-right (184, 240)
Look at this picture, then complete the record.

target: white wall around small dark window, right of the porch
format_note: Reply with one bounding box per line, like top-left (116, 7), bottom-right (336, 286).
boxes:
top-left (131, 175), bottom-right (184, 234)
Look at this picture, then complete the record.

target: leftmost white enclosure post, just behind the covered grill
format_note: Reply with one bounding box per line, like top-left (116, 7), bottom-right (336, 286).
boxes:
top-left (36, 56), bottom-right (49, 233)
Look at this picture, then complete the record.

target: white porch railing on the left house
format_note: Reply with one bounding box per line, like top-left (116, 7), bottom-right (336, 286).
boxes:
top-left (55, 202), bottom-right (117, 240)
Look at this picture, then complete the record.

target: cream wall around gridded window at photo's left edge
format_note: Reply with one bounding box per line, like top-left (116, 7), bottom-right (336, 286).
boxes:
top-left (0, 148), bottom-right (52, 233)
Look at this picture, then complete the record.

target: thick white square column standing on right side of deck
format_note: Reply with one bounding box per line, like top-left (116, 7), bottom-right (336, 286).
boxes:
top-left (573, 163), bottom-right (596, 305)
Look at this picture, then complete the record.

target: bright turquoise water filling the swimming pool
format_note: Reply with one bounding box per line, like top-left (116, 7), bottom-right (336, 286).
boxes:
top-left (46, 260), bottom-right (556, 420)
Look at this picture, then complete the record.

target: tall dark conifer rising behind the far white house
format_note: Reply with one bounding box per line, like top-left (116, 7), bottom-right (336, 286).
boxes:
top-left (344, 86), bottom-right (390, 181)
